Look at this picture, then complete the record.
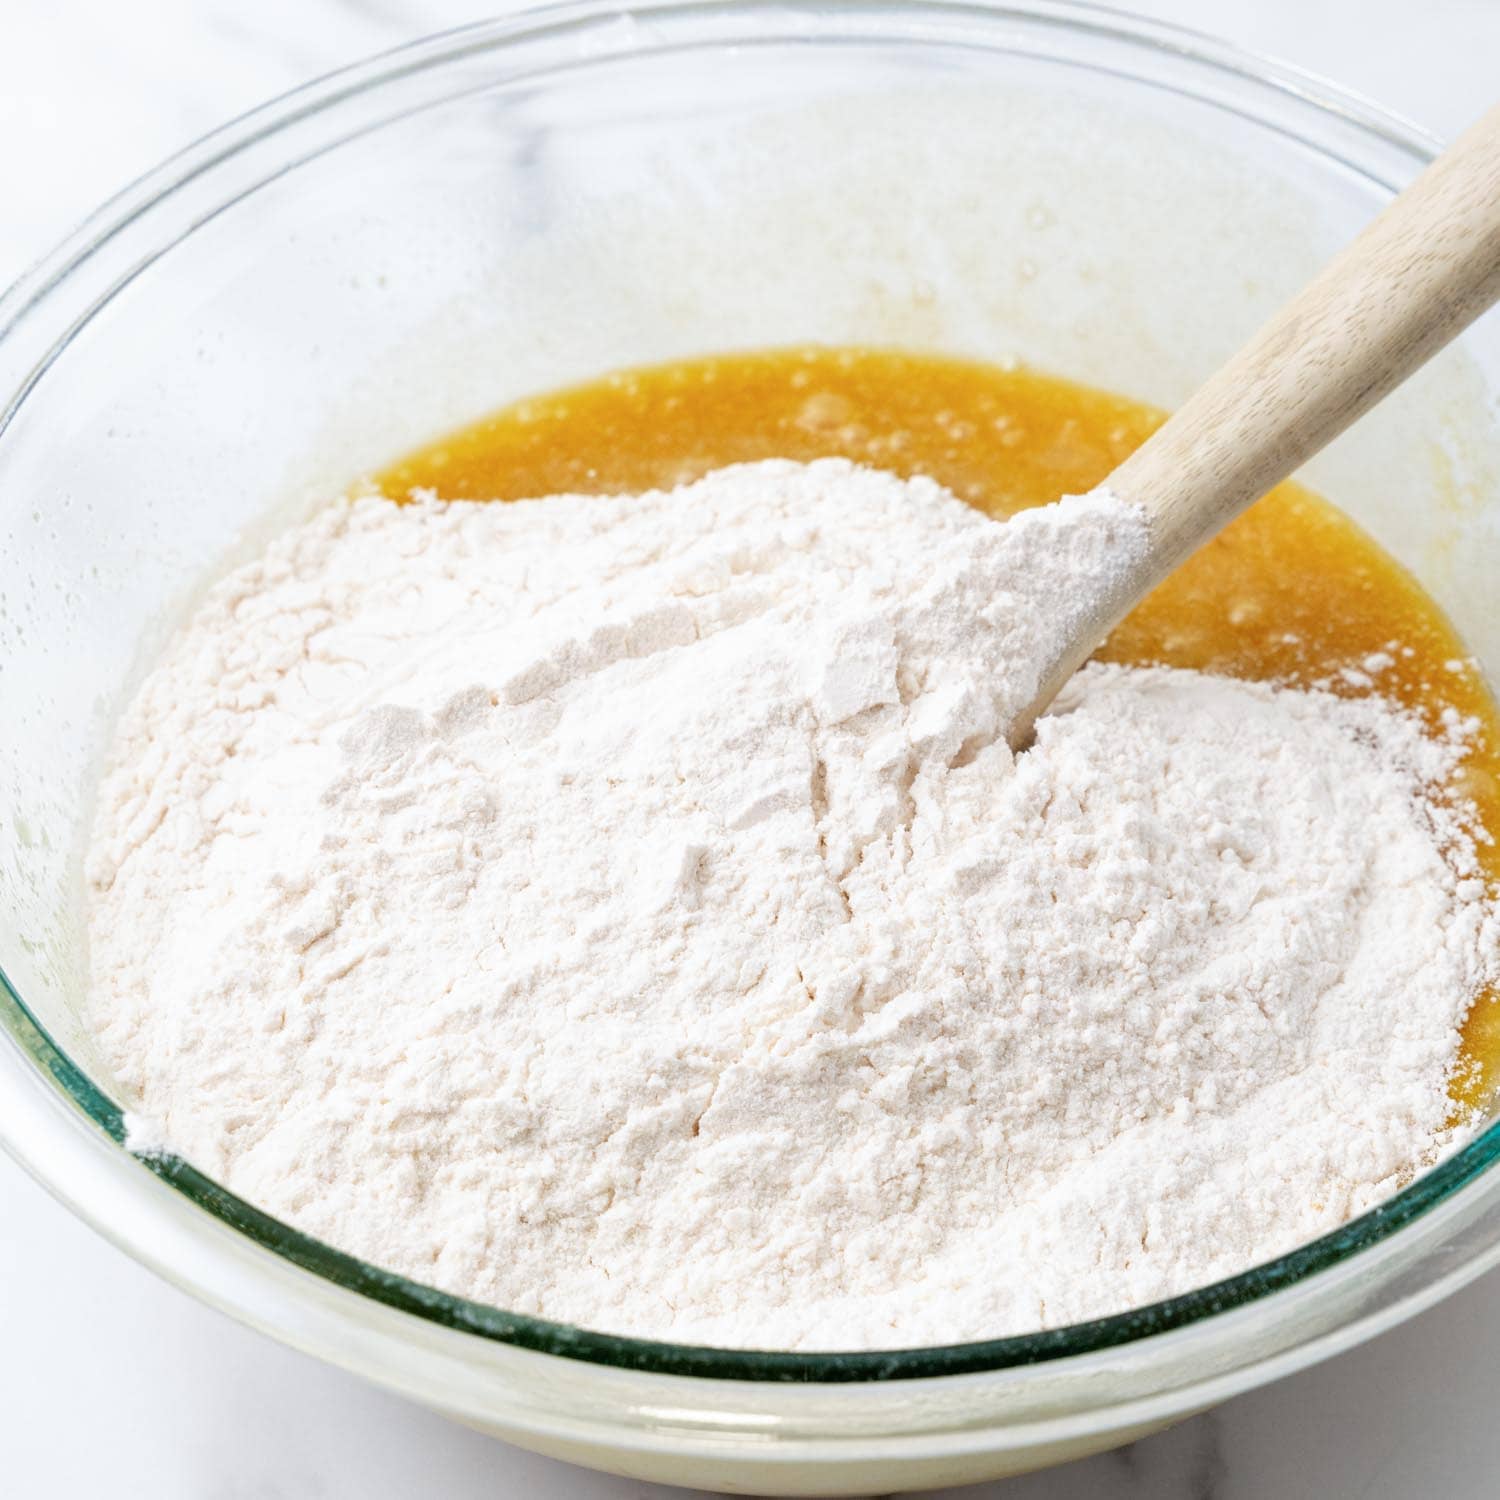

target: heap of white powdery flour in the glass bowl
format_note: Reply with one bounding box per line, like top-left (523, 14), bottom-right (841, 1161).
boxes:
top-left (89, 461), bottom-right (1497, 1349)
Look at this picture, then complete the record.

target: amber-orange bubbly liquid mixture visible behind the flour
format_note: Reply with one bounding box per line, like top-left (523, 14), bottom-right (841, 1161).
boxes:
top-left (378, 350), bottom-right (1500, 1104)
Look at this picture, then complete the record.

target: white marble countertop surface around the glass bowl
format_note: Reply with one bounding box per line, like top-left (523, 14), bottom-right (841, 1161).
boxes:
top-left (0, 0), bottom-right (1500, 1500)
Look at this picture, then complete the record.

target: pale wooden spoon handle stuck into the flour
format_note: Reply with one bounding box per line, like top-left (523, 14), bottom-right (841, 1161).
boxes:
top-left (1008, 108), bottom-right (1500, 749)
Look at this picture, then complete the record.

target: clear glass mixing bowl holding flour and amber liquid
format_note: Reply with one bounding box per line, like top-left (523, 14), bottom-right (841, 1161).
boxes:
top-left (0, 0), bottom-right (1500, 1494)
